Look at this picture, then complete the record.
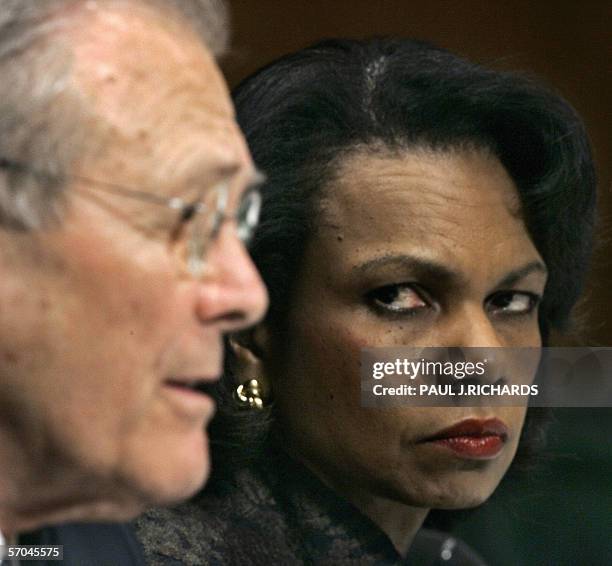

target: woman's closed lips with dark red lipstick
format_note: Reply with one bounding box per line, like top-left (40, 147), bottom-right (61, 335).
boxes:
top-left (422, 419), bottom-right (508, 460)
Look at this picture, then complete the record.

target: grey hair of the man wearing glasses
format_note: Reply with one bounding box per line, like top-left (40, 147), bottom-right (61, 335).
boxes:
top-left (0, 0), bottom-right (229, 230)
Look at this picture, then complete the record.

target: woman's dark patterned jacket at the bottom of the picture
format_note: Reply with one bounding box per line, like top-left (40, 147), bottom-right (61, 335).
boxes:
top-left (136, 457), bottom-right (483, 566)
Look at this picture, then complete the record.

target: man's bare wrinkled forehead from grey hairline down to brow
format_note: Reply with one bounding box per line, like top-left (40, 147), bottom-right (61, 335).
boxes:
top-left (57, 3), bottom-right (250, 193)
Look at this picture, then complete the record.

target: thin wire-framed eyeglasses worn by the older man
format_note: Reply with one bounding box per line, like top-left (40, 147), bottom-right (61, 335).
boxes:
top-left (0, 157), bottom-right (261, 277)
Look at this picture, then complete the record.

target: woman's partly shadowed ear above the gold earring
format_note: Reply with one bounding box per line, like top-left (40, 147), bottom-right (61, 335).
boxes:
top-left (229, 324), bottom-right (271, 396)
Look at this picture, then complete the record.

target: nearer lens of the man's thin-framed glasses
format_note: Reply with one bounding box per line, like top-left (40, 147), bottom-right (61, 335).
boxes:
top-left (187, 183), bottom-right (227, 275)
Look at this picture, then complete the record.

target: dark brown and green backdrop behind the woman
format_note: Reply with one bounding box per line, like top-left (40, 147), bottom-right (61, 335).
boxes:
top-left (224, 0), bottom-right (612, 566)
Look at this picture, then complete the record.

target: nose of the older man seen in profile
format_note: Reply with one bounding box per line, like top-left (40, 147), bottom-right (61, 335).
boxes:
top-left (197, 221), bottom-right (268, 332)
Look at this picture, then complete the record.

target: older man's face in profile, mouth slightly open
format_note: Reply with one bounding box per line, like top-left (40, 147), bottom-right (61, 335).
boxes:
top-left (0, 6), bottom-right (267, 528)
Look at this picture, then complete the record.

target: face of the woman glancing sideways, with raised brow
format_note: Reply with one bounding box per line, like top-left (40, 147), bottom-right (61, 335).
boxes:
top-left (268, 151), bottom-right (546, 508)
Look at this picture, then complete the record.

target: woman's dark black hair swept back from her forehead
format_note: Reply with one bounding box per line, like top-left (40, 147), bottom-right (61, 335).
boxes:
top-left (211, 39), bottom-right (596, 496)
